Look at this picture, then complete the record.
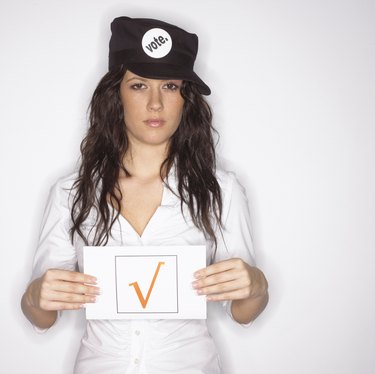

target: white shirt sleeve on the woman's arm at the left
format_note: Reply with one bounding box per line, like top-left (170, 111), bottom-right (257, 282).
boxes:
top-left (30, 183), bottom-right (77, 333)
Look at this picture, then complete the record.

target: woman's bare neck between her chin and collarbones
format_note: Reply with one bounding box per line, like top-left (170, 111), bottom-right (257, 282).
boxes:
top-left (123, 145), bottom-right (167, 179)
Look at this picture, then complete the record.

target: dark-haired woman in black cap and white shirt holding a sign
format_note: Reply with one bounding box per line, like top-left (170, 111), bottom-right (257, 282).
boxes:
top-left (21, 17), bottom-right (268, 374)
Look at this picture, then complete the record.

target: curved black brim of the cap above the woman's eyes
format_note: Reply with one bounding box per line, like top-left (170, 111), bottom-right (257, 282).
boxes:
top-left (125, 62), bottom-right (211, 95)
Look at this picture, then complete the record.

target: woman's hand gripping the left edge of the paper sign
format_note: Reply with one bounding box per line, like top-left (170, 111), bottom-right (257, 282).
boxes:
top-left (25, 269), bottom-right (100, 311)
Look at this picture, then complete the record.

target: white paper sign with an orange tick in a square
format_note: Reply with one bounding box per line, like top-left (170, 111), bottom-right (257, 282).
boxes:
top-left (83, 246), bottom-right (206, 319)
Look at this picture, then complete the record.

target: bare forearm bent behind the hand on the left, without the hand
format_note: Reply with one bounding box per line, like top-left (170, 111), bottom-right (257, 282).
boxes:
top-left (21, 283), bottom-right (57, 329)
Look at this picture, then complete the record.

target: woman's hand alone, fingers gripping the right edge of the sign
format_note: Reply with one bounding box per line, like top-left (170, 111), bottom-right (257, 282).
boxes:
top-left (193, 258), bottom-right (268, 301)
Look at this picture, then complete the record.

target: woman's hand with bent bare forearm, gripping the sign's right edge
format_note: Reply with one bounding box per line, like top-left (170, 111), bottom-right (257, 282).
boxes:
top-left (193, 258), bottom-right (268, 323)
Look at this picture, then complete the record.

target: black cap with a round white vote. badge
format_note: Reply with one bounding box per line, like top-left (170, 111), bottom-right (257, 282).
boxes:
top-left (109, 17), bottom-right (211, 95)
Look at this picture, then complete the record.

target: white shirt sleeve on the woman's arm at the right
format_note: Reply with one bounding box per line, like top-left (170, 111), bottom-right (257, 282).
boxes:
top-left (213, 173), bottom-right (255, 326)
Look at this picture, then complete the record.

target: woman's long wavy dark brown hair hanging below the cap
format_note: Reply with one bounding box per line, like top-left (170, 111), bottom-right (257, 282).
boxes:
top-left (70, 66), bottom-right (222, 246)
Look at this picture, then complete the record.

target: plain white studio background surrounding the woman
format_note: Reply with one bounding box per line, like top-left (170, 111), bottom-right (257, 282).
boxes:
top-left (0, 0), bottom-right (375, 374)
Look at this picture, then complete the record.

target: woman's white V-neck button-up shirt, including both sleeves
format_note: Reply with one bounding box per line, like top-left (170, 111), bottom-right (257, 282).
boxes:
top-left (32, 171), bottom-right (254, 374)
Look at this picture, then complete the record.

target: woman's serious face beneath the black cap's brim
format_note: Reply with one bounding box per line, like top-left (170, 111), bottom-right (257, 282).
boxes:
top-left (120, 70), bottom-right (184, 150)
